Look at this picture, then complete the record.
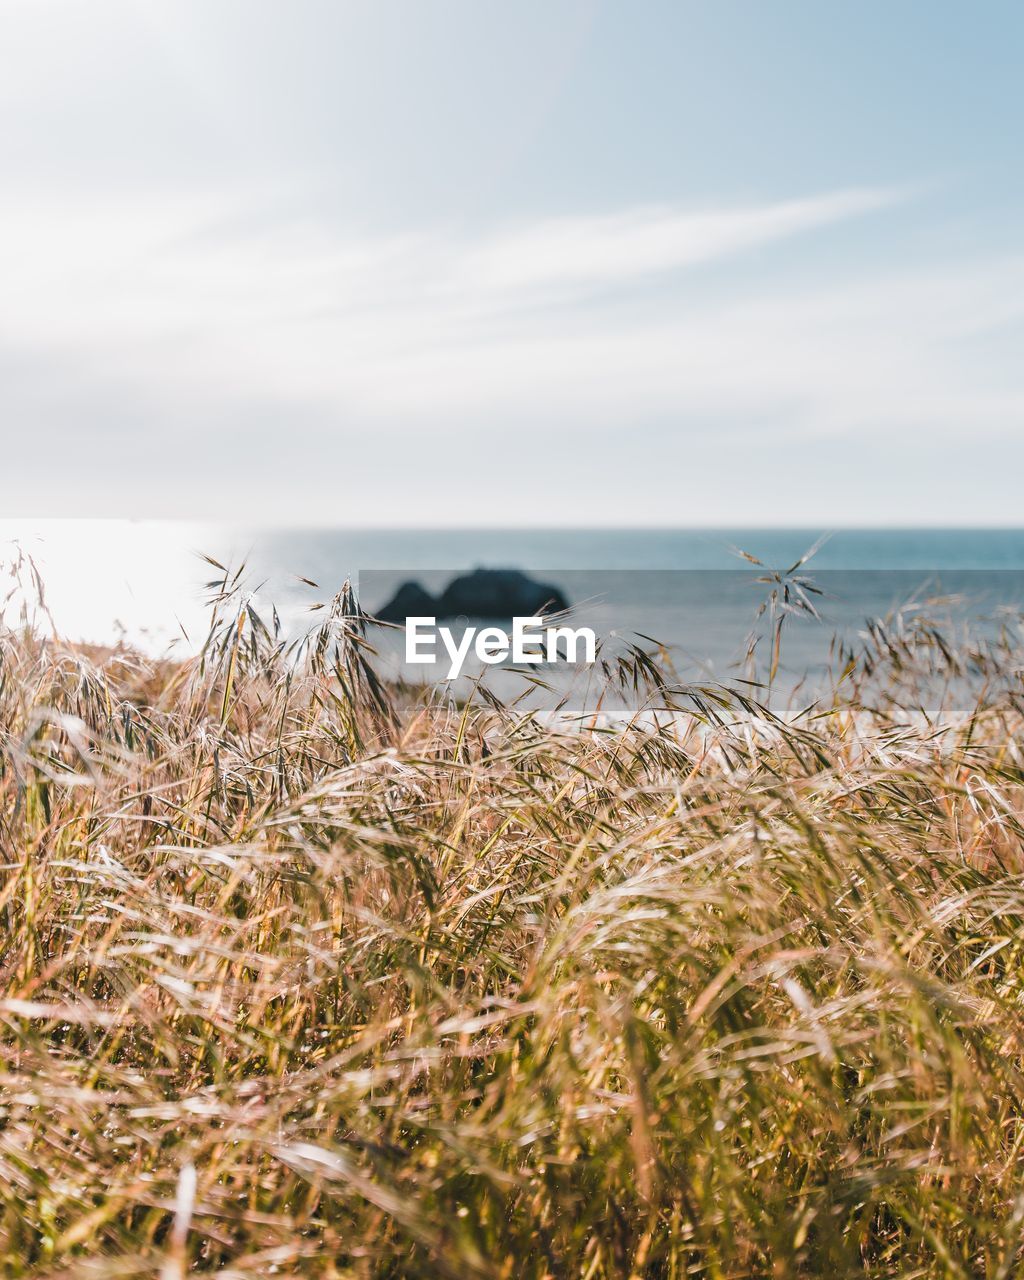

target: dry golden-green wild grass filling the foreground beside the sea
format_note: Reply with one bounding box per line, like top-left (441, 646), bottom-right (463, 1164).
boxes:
top-left (0, 565), bottom-right (1024, 1280)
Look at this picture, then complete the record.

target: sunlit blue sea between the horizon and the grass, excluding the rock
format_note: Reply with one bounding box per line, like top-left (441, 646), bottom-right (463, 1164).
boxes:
top-left (0, 521), bottom-right (1024, 701)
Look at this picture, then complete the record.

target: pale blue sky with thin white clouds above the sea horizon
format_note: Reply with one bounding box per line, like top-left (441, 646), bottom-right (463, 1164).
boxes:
top-left (0, 0), bottom-right (1024, 527)
